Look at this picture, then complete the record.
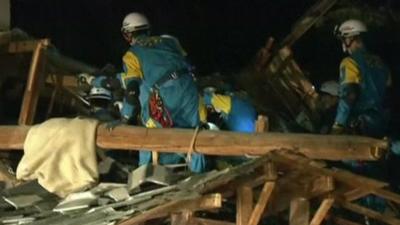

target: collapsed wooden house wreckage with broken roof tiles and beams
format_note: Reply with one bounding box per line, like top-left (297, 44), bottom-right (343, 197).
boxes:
top-left (0, 0), bottom-right (400, 225)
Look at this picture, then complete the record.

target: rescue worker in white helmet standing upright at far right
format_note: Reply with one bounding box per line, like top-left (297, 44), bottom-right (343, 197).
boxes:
top-left (332, 20), bottom-right (391, 137)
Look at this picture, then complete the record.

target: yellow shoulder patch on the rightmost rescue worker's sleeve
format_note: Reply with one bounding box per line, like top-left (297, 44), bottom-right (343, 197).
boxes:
top-left (340, 57), bottom-right (361, 84)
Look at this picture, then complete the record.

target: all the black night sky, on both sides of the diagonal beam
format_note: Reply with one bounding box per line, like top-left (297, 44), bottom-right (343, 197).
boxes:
top-left (5, 0), bottom-right (400, 128)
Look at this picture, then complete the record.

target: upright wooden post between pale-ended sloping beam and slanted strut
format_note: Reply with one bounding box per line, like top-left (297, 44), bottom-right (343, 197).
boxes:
top-left (236, 185), bottom-right (253, 225)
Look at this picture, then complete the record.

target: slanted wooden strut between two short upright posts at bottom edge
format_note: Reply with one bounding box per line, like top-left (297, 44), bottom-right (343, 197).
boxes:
top-left (248, 181), bottom-right (275, 225)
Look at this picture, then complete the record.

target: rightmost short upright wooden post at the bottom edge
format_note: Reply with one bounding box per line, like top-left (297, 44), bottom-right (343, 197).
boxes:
top-left (289, 198), bottom-right (310, 225)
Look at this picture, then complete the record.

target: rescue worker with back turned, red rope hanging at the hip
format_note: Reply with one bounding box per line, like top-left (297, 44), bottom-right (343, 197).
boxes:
top-left (78, 12), bottom-right (205, 172)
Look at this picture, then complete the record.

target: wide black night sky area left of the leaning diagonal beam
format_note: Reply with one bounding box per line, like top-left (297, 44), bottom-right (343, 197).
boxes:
top-left (12, 0), bottom-right (324, 73)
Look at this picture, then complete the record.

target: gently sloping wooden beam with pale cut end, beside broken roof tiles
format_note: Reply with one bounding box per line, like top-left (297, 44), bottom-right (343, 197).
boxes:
top-left (119, 194), bottom-right (222, 225)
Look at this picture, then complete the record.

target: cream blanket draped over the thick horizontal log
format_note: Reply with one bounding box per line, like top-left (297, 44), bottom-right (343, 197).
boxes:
top-left (17, 118), bottom-right (98, 197)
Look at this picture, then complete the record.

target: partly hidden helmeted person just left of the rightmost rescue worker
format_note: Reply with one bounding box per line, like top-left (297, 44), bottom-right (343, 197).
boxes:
top-left (318, 80), bottom-right (339, 134)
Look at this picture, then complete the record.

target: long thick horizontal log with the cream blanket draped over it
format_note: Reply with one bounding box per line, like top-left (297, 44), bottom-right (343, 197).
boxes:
top-left (0, 125), bottom-right (388, 160)
